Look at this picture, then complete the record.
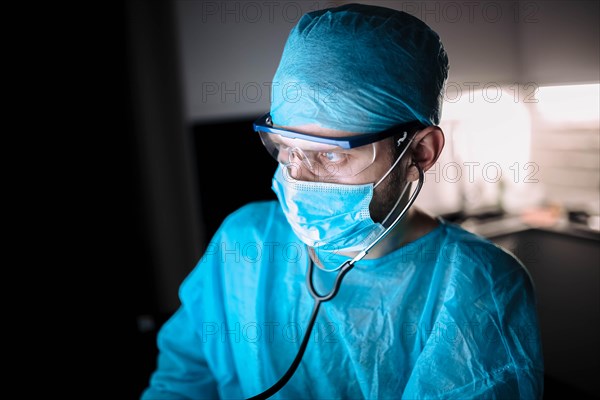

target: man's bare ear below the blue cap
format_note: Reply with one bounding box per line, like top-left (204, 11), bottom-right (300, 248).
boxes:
top-left (406, 125), bottom-right (446, 182)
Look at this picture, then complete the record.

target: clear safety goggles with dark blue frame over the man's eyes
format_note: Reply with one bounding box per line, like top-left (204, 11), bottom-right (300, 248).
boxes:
top-left (254, 113), bottom-right (424, 177)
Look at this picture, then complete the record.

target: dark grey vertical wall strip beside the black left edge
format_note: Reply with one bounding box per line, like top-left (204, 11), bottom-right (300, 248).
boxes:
top-left (120, 0), bottom-right (199, 398)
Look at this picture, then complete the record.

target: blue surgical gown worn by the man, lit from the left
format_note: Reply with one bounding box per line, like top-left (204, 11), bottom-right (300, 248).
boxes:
top-left (142, 201), bottom-right (543, 400)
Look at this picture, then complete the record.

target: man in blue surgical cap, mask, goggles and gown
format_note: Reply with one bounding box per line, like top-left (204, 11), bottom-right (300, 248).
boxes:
top-left (141, 4), bottom-right (543, 400)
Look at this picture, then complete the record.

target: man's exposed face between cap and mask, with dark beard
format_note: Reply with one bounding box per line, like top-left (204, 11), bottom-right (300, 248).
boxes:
top-left (279, 125), bottom-right (409, 222)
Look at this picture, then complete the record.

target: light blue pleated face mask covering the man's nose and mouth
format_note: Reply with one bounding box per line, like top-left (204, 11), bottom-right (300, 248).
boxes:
top-left (272, 164), bottom-right (385, 251)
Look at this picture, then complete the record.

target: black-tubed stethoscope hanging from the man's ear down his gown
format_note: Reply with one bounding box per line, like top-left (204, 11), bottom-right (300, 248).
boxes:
top-left (247, 163), bottom-right (425, 400)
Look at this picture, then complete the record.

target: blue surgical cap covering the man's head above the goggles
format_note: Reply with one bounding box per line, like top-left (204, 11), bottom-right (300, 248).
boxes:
top-left (270, 4), bottom-right (448, 133)
